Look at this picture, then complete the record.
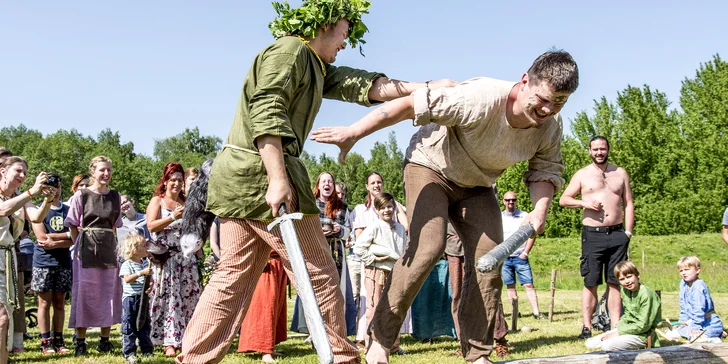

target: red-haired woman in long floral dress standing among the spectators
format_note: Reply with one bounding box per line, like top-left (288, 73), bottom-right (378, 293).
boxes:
top-left (147, 162), bottom-right (202, 356)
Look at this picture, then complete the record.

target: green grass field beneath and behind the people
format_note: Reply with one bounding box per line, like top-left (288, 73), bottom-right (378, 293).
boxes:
top-left (11, 234), bottom-right (728, 364)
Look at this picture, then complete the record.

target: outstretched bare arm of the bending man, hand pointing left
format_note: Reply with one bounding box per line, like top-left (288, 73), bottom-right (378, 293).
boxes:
top-left (311, 96), bottom-right (415, 163)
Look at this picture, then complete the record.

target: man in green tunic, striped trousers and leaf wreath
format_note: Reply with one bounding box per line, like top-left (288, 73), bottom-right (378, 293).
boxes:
top-left (177, 0), bottom-right (453, 363)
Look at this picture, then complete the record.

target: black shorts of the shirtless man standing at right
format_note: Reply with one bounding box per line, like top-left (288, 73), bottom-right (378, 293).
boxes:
top-left (580, 224), bottom-right (629, 287)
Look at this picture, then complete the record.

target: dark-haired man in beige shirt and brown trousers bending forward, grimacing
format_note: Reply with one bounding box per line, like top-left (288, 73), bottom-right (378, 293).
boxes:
top-left (311, 51), bottom-right (579, 363)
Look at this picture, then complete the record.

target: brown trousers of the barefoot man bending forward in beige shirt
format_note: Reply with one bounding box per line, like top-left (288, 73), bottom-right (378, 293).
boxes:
top-left (369, 163), bottom-right (503, 361)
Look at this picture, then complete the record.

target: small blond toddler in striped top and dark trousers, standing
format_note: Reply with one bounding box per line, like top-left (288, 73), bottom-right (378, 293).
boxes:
top-left (119, 234), bottom-right (154, 364)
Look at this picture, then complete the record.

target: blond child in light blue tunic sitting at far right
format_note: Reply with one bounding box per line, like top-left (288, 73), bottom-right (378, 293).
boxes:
top-left (667, 256), bottom-right (723, 343)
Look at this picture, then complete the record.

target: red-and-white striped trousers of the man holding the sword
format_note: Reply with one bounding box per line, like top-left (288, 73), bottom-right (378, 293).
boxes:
top-left (176, 216), bottom-right (361, 364)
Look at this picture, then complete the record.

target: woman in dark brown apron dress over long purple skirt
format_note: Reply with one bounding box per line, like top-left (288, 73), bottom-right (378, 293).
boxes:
top-left (65, 156), bottom-right (122, 356)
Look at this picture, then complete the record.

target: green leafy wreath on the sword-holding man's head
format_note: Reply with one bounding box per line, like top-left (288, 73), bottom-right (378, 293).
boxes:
top-left (268, 0), bottom-right (372, 55)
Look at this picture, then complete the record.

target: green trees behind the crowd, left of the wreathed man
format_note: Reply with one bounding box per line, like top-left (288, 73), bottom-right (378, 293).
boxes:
top-left (0, 125), bottom-right (222, 212)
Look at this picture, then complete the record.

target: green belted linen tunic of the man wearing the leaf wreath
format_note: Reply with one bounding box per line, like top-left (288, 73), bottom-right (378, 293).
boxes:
top-left (207, 36), bottom-right (384, 220)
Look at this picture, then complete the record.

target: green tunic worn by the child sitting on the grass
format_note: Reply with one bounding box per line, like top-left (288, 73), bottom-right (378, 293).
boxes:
top-left (617, 283), bottom-right (662, 348)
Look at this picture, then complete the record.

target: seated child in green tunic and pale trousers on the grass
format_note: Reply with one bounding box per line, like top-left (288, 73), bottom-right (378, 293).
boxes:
top-left (586, 261), bottom-right (662, 351)
